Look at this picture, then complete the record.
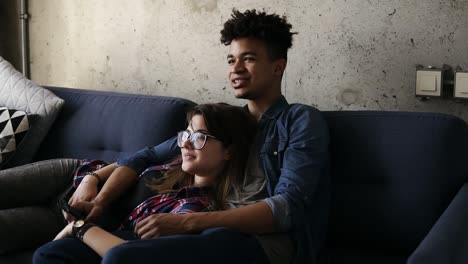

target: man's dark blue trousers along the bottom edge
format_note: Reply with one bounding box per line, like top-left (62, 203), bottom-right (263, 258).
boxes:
top-left (33, 228), bottom-right (269, 264)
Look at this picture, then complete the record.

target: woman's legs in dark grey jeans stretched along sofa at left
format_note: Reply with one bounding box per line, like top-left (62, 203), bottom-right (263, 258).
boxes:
top-left (0, 159), bottom-right (79, 254)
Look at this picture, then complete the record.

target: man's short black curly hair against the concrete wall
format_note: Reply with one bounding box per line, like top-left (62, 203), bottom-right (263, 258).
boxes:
top-left (221, 9), bottom-right (297, 60)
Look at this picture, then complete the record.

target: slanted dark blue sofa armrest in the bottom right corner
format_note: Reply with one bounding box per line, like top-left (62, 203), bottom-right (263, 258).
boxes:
top-left (408, 183), bottom-right (468, 264)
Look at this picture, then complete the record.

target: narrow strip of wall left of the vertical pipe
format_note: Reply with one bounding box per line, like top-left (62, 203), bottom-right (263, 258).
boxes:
top-left (0, 0), bottom-right (21, 71)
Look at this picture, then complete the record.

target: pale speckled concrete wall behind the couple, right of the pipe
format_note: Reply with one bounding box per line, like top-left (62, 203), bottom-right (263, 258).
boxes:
top-left (30, 0), bottom-right (468, 120)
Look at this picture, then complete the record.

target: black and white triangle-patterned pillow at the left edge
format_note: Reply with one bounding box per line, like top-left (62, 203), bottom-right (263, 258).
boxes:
top-left (0, 107), bottom-right (30, 167)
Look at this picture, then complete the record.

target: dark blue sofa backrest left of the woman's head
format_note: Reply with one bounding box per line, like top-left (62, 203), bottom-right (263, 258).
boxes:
top-left (35, 87), bottom-right (195, 162)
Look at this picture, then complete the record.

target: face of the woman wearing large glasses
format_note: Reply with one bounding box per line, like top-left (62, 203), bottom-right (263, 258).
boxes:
top-left (181, 115), bottom-right (229, 186)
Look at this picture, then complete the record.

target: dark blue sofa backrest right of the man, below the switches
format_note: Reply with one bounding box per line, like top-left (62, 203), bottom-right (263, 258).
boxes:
top-left (324, 111), bottom-right (468, 254)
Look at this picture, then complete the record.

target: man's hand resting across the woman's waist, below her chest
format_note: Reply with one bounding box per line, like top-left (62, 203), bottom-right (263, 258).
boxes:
top-left (135, 214), bottom-right (192, 239)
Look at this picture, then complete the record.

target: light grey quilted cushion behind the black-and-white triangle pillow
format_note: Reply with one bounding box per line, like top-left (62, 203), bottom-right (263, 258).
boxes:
top-left (0, 57), bottom-right (63, 167)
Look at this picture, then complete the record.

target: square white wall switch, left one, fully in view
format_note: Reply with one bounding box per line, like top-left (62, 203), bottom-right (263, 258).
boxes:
top-left (416, 69), bottom-right (443, 97)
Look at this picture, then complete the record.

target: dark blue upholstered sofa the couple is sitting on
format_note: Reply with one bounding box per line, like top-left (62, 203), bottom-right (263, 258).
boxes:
top-left (0, 87), bottom-right (468, 264)
